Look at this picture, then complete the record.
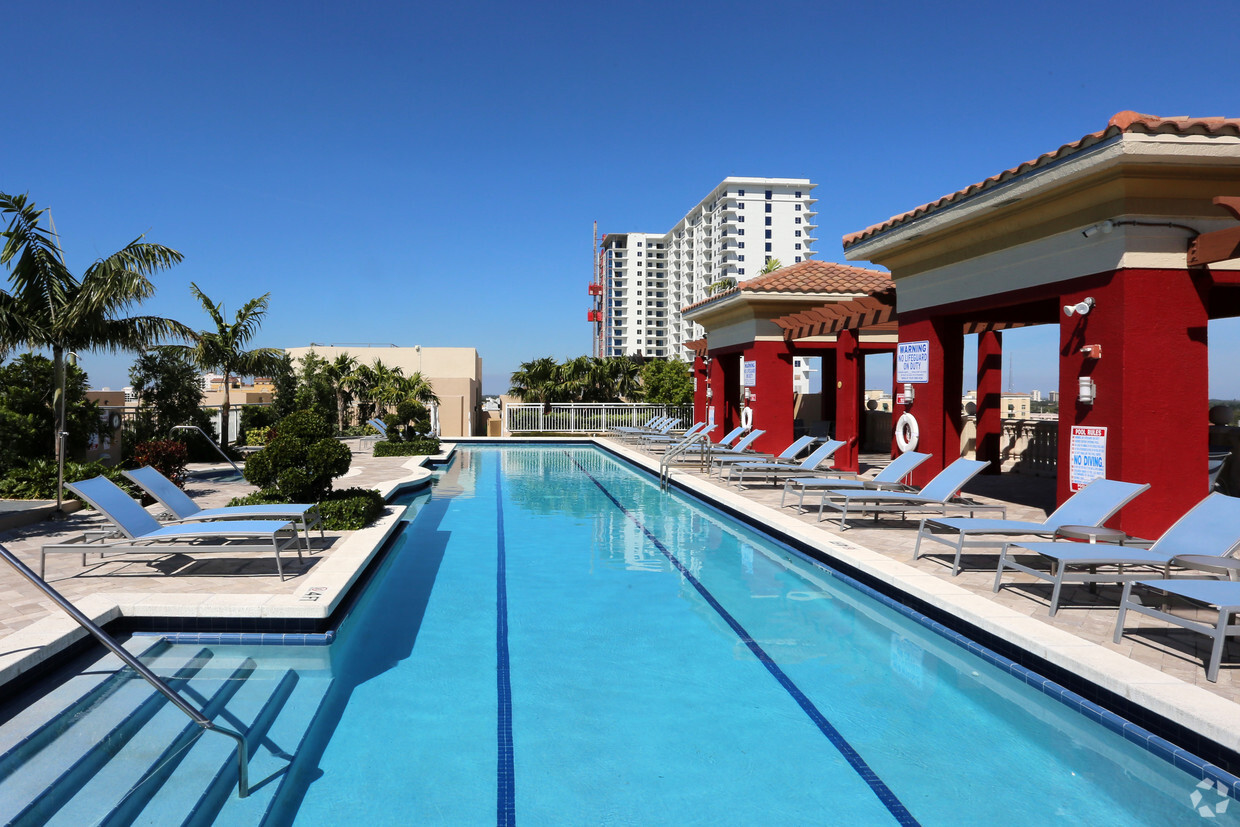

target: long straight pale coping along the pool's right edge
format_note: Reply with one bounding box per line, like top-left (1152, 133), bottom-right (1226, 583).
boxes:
top-left (591, 439), bottom-right (1240, 768)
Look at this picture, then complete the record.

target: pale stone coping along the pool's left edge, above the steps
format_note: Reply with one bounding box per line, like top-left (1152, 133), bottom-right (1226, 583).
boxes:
top-left (0, 441), bottom-right (443, 686)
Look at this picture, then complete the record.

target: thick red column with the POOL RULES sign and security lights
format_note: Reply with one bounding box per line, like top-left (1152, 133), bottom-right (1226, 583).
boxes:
top-left (1058, 269), bottom-right (1209, 537)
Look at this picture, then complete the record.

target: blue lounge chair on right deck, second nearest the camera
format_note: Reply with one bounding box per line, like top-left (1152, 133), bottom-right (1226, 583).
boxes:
top-left (994, 492), bottom-right (1240, 616)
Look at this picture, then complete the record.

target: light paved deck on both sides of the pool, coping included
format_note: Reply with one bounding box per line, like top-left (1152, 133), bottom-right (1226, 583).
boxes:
top-left (0, 440), bottom-right (1240, 768)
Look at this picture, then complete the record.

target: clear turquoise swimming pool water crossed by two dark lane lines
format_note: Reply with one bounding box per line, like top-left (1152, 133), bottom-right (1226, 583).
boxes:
top-left (256, 445), bottom-right (1240, 825)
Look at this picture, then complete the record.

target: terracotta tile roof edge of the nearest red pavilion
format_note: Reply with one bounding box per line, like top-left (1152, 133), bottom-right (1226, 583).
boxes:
top-left (843, 112), bottom-right (1240, 249)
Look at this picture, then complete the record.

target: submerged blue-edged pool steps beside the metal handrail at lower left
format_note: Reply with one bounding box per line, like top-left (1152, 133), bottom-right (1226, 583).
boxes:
top-left (0, 637), bottom-right (330, 826)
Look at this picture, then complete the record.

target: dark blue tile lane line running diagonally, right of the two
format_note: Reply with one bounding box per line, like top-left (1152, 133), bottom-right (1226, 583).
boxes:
top-left (564, 451), bottom-right (919, 825)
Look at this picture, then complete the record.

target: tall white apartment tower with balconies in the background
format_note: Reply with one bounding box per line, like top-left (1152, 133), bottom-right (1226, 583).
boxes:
top-left (588, 179), bottom-right (817, 358)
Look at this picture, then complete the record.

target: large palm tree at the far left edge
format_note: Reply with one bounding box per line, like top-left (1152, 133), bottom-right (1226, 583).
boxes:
top-left (0, 192), bottom-right (193, 490)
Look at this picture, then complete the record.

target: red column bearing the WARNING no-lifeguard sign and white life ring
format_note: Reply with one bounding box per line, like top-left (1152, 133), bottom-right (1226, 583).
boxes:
top-left (895, 316), bottom-right (965, 485)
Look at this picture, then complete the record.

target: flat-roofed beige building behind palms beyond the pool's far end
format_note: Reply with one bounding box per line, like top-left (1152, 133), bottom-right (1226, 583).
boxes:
top-left (285, 345), bottom-right (484, 438)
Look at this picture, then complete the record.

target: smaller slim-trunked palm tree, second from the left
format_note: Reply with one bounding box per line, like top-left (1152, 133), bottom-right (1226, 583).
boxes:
top-left (172, 281), bottom-right (284, 448)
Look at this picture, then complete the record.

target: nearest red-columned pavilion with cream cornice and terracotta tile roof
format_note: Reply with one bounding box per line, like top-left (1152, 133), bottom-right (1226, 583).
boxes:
top-left (843, 113), bottom-right (1240, 536)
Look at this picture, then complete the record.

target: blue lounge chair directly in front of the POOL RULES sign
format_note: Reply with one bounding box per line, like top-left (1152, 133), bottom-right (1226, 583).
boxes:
top-left (913, 480), bottom-right (1149, 574)
